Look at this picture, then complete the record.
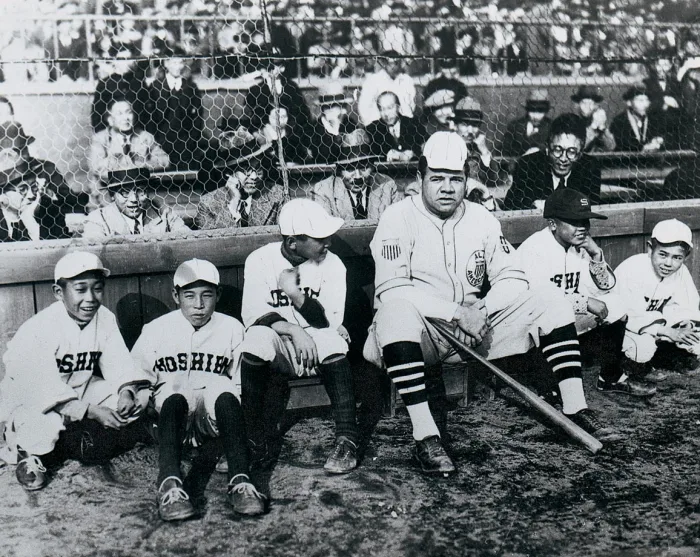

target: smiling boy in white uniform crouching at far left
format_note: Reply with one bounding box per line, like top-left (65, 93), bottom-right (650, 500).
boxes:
top-left (0, 251), bottom-right (151, 491)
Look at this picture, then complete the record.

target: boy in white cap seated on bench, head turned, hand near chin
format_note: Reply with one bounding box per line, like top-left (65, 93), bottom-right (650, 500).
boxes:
top-left (241, 199), bottom-right (358, 474)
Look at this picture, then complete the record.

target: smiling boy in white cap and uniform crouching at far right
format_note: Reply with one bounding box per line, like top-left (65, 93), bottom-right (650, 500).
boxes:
top-left (615, 219), bottom-right (700, 370)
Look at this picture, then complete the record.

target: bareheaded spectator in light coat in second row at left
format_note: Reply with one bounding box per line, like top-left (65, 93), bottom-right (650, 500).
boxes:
top-left (90, 98), bottom-right (170, 186)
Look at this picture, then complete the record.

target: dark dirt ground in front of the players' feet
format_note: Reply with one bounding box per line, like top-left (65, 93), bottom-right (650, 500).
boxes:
top-left (0, 360), bottom-right (700, 557)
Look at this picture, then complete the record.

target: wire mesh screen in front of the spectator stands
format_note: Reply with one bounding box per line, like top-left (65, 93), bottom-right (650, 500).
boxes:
top-left (0, 0), bottom-right (700, 241)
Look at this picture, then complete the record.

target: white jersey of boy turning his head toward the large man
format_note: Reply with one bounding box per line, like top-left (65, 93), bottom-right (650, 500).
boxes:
top-left (241, 242), bottom-right (346, 329)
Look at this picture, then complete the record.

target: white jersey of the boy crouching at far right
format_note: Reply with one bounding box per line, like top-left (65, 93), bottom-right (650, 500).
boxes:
top-left (615, 253), bottom-right (700, 332)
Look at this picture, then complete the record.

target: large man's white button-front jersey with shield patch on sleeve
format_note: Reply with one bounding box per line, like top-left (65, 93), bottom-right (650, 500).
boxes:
top-left (370, 195), bottom-right (527, 320)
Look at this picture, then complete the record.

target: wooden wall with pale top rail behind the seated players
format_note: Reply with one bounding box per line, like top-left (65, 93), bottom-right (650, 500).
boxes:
top-left (0, 200), bottom-right (700, 379)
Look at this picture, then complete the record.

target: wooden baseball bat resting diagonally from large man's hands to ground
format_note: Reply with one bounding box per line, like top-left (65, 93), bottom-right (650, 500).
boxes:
top-left (429, 319), bottom-right (603, 454)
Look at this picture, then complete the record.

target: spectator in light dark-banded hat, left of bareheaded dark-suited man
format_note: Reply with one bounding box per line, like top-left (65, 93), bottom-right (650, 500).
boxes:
top-left (302, 83), bottom-right (357, 164)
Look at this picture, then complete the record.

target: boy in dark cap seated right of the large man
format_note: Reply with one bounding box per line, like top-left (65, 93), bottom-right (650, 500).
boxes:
top-left (518, 188), bottom-right (656, 397)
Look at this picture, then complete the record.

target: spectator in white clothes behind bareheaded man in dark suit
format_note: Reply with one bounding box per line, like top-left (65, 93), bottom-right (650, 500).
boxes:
top-left (357, 50), bottom-right (416, 126)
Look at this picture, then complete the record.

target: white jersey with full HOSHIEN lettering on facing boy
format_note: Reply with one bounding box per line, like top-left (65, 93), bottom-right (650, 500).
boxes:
top-left (131, 309), bottom-right (243, 394)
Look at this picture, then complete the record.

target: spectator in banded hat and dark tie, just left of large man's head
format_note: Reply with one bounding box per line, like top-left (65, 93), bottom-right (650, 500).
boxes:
top-left (311, 130), bottom-right (403, 220)
